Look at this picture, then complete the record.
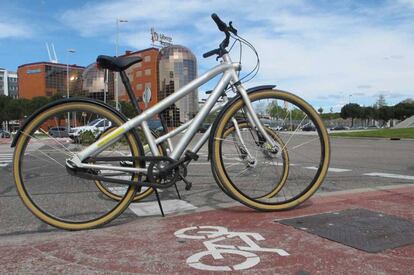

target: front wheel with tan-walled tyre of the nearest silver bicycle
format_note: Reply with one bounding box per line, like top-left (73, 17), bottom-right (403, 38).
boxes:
top-left (210, 90), bottom-right (330, 211)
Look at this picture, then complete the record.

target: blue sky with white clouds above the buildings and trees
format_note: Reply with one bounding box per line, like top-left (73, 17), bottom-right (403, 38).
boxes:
top-left (0, 0), bottom-right (414, 112)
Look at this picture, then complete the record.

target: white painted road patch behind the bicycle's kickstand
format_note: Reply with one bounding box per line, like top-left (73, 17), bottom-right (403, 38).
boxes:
top-left (129, 200), bottom-right (197, 216)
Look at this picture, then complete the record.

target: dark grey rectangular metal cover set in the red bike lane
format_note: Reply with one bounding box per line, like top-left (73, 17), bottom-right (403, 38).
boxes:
top-left (279, 209), bottom-right (414, 252)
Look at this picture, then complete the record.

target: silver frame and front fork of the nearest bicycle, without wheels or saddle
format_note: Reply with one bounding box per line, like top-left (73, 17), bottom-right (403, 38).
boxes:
top-left (66, 54), bottom-right (278, 172)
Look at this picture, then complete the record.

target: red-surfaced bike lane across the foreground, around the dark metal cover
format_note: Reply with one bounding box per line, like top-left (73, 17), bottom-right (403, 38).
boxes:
top-left (0, 187), bottom-right (414, 274)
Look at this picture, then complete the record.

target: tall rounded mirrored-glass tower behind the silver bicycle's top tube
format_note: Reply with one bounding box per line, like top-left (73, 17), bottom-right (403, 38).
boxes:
top-left (158, 45), bottom-right (198, 127)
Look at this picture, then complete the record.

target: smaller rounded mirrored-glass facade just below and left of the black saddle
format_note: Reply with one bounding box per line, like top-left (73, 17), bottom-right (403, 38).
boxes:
top-left (82, 63), bottom-right (114, 101)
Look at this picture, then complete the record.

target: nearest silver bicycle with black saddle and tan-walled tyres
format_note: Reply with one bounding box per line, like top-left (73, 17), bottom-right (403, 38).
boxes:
top-left (12, 14), bottom-right (330, 230)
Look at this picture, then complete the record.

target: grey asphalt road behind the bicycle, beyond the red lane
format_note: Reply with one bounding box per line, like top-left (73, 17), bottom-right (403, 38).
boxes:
top-left (0, 134), bottom-right (414, 236)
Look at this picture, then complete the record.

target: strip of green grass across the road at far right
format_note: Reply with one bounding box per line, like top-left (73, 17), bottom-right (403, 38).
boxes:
top-left (331, 128), bottom-right (414, 139)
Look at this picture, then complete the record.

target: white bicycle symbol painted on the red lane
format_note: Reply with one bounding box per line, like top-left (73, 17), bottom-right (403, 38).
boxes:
top-left (174, 226), bottom-right (289, 271)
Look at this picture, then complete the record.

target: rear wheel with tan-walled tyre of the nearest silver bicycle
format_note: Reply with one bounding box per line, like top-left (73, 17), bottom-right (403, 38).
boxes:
top-left (13, 100), bottom-right (142, 230)
